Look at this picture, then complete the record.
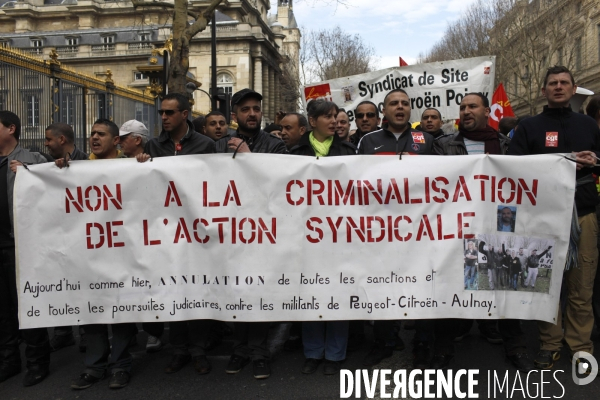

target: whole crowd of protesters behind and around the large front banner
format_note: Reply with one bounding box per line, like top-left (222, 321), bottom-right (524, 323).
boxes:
top-left (0, 66), bottom-right (600, 389)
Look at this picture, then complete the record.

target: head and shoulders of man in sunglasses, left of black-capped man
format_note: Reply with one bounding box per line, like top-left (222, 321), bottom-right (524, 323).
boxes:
top-left (136, 93), bottom-right (215, 162)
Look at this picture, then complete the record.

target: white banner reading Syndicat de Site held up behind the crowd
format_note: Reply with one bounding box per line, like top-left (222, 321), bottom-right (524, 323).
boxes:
top-left (302, 56), bottom-right (496, 126)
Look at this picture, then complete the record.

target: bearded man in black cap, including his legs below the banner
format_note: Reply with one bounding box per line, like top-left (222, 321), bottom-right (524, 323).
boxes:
top-left (217, 89), bottom-right (287, 379)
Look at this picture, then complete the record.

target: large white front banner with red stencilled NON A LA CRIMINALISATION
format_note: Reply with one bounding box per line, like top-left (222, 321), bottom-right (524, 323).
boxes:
top-left (15, 154), bottom-right (575, 328)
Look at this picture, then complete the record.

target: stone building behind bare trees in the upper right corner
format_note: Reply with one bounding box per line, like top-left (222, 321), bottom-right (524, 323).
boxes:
top-left (490, 0), bottom-right (600, 116)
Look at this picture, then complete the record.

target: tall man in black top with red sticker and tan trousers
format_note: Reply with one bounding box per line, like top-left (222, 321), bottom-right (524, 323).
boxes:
top-left (509, 66), bottom-right (600, 369)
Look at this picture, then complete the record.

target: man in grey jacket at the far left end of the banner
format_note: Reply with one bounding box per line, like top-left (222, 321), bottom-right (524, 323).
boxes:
top-left (0, 111), bottom-right (50, 386)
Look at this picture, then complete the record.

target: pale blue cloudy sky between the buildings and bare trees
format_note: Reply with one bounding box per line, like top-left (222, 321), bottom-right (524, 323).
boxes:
top-left (270, 0), bottom-right (475, 69)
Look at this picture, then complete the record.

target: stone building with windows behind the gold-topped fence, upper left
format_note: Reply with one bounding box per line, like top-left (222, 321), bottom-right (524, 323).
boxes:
top-left (0, 0), bottom-right (300, 121)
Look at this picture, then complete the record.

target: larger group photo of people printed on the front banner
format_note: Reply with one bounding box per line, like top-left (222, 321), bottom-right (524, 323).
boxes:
top-left (464, 234), bottom-right (554, 293)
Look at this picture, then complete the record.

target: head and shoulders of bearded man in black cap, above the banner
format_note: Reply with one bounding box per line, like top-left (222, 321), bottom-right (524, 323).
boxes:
top-left (216, 89), bottom-right (287, 154)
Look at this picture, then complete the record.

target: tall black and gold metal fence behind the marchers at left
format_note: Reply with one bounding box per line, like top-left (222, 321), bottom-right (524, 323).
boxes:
top-left (0, 48), bottom-right (160, 153)
